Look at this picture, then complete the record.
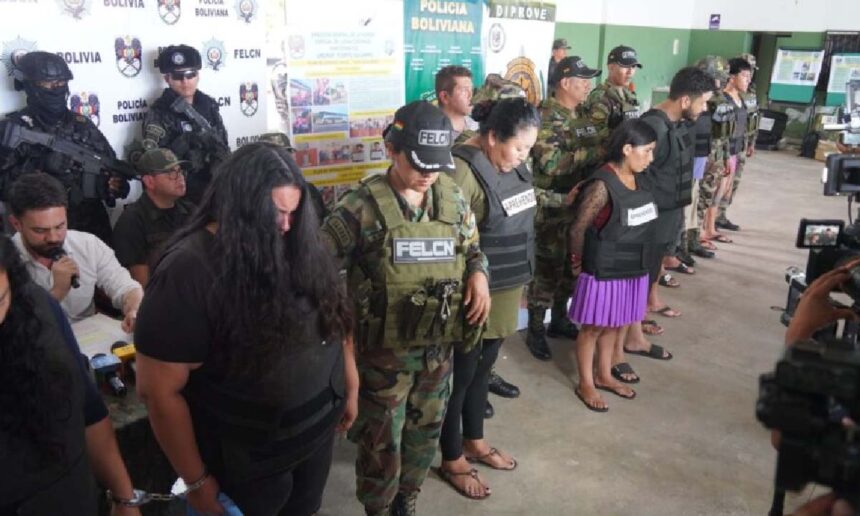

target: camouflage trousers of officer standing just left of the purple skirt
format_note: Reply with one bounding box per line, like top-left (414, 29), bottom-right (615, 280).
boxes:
top-left (528, 209), bottom-right (574, 308)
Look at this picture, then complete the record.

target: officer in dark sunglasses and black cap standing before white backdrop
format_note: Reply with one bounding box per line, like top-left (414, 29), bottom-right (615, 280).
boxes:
top-left (143, 45), bottom-right (230, 204)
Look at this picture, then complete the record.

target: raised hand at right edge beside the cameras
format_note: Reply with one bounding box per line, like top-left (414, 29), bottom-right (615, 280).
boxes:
top-left (785, 259), bottom-right (860, 345)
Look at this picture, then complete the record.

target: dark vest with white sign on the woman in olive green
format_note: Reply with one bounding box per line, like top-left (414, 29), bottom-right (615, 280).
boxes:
top-left (452, 145), bottom-right (537, 291)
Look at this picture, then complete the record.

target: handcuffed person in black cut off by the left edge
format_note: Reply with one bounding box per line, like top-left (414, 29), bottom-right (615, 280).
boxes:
top-left (0, 235), bottom-right (140, 516)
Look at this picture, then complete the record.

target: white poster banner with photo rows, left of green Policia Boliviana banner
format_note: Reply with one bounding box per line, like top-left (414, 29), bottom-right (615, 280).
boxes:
top-left (285, 0), bottom-right (403, 192)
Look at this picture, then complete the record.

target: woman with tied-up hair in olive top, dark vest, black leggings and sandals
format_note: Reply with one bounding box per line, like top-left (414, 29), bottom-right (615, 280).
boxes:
top-left (437, 98), bottom-right (540, 499)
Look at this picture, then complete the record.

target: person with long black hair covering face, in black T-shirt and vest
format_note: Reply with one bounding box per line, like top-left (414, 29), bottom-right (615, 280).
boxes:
top-left (135, 143), bottom-right (358, 516)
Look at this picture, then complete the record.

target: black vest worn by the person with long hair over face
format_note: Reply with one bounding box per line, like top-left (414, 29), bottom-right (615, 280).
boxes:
top-left (183, 296), bottom-right (345, 485)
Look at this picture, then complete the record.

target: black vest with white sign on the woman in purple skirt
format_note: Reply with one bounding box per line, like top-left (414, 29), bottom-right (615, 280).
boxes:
top-left (582, 168), bottom-right (657, 279)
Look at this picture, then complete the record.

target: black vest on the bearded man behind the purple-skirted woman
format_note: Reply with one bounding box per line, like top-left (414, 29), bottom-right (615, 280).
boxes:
top-left (642, 109), bottom-right (695, 210)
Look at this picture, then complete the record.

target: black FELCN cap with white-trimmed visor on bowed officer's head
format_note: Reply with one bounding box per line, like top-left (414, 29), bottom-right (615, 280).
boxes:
top-left (383, 100), bottom-right (454, 174)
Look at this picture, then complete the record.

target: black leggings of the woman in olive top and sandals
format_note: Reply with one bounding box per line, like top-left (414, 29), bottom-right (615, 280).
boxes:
top-left (439, 339), bottom-right (504, 460)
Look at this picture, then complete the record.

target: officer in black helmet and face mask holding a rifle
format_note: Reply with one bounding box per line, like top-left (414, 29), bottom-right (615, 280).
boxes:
top-left (0, 51), bottom-right (129, 243)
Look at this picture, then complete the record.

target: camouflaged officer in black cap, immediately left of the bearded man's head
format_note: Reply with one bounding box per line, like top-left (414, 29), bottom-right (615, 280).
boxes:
top-left (584, 45), bottom-right (642, 132)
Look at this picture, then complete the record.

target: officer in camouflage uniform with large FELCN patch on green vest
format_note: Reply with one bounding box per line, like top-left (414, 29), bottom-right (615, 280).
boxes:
top-left (321, 101), bottom-right (490, 515)
